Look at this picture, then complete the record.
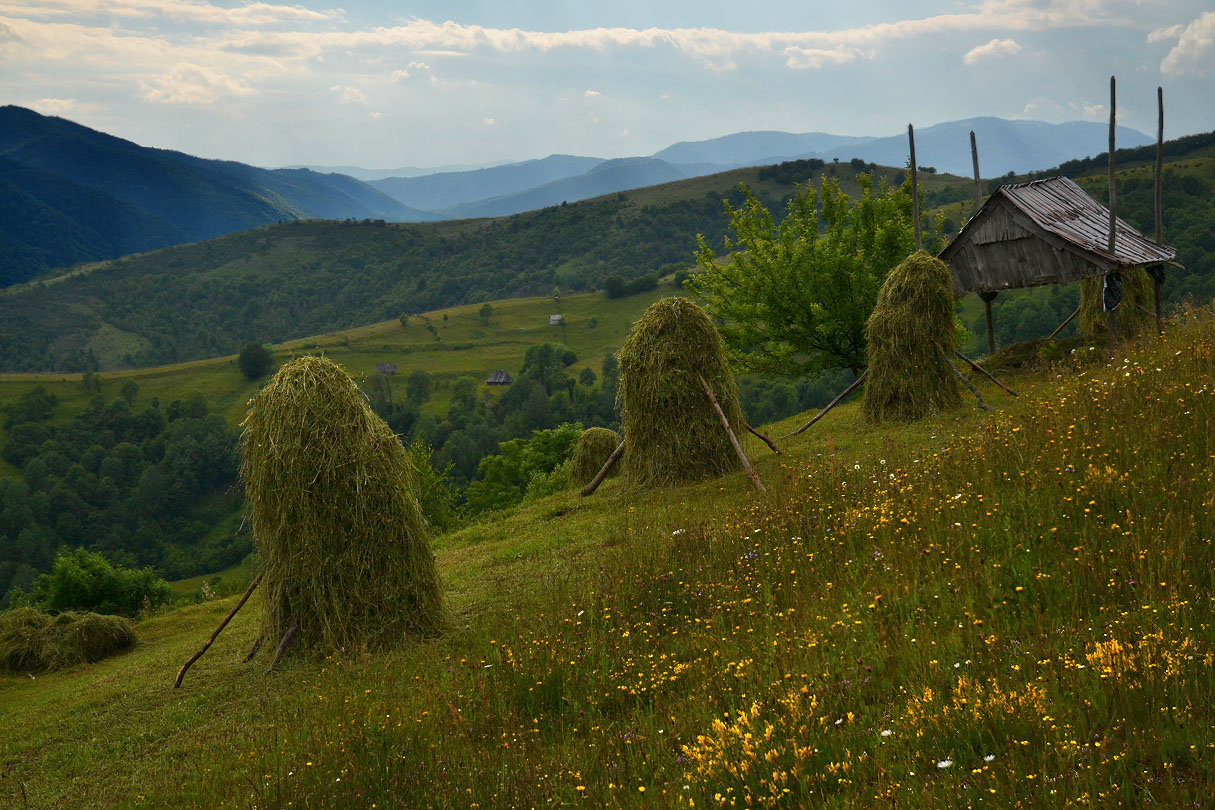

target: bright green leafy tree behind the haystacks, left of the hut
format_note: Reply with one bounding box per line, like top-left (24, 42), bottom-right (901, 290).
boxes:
top-left (688, 175), bottom-right (912, 375)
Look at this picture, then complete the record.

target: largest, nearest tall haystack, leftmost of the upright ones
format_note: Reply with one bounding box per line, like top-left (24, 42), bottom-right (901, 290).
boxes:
top-left (241, 357), bottom-right (441, 651)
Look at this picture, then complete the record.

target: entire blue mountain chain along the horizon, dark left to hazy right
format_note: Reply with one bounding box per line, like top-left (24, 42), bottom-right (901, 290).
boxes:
top-left (0, 106), bottom-right (1151, 287)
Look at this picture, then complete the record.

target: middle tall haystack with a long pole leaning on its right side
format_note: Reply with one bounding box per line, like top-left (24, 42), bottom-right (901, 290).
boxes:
top-left (617, 298), bottom-right (745, 487)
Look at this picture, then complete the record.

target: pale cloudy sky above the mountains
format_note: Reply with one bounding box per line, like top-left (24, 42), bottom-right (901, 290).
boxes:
top-left (0, 0), bottom-right (1215, 169)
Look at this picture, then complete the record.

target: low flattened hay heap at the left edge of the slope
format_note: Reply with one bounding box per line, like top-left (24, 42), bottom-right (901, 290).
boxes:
top-left (0, 607), bottom-right (135, 674)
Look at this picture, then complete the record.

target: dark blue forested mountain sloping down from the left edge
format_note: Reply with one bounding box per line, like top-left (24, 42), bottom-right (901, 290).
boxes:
top-left (0, 106), bottom-right (440, 285)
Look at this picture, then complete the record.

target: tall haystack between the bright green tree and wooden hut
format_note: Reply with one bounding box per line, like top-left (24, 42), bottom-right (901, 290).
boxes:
top-left (860, 250), bottom-right (961, 421)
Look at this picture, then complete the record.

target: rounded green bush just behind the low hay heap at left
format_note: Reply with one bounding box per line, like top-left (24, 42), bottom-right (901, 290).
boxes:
top-left (12, 549), bottom-right (169, 616)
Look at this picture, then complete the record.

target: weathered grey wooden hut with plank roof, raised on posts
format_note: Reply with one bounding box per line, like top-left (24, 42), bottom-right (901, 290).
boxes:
top-left (939, 177), bottom-right (1177, 298)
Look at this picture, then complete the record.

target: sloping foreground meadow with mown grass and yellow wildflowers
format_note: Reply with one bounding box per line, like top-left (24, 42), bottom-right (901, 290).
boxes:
top-left (0, 306), bottom-right (1215, 809)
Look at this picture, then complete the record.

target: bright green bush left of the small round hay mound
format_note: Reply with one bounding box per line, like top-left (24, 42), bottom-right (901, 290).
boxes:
top-left (465, 423), bottom-right (582, 514)
